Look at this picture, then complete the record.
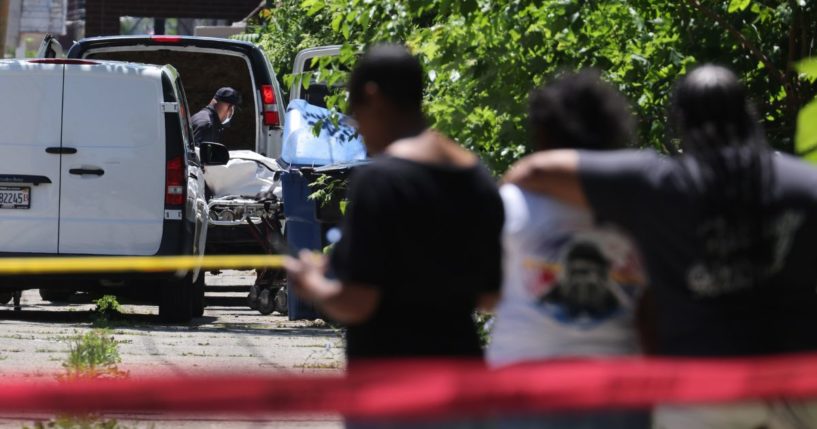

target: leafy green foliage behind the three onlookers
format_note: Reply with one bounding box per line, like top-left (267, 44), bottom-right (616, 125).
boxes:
top-left (249, 0), bottom-right (817, 172)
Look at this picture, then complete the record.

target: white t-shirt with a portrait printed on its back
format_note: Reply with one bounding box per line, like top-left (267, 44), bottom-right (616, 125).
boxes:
top-left (487, 185), bottom-right (646, 366)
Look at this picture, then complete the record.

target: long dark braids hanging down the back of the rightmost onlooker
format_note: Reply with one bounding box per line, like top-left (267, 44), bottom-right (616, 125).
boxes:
top-left (670, 65), bottom-right (773, 292)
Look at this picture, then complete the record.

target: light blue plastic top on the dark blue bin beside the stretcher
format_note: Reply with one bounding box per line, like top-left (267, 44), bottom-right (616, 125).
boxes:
top-left (281, 100), bottom-right (366, 167)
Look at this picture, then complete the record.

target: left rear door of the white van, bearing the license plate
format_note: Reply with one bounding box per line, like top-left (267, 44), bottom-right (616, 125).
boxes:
top-left (0, 61), bottom-right (63, 253)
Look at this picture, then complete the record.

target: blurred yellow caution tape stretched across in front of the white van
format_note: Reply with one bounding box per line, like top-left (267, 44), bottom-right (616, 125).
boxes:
top-left (0, 255), bottom-right (284, 275)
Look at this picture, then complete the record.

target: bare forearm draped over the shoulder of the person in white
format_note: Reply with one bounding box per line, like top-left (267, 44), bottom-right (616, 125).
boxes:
top-left (503, 149), bottom-right (589, 208)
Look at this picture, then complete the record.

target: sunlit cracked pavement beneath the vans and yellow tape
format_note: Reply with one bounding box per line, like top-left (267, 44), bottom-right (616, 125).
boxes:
top-left (0, 271), bottom-right (345, 428)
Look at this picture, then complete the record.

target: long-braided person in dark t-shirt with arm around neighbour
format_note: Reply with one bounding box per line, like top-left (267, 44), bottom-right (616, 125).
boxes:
top-left (506, 66), bottom-right (817, 356)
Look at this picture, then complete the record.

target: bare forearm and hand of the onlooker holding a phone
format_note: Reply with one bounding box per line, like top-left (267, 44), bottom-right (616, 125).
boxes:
top-left (284, 251), bottom-right (380, 325)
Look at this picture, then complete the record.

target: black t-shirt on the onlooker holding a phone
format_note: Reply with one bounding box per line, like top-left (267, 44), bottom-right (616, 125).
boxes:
top-left (331, 157), bottom-right (504, 359)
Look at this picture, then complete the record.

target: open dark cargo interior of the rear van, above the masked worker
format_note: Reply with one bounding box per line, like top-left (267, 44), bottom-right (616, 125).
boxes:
top-left (85, 50), bottom-right (255, 151)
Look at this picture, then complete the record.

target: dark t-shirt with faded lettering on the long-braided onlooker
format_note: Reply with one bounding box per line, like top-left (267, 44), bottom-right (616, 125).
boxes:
top-left (579, 151), bottom-right (817, 356)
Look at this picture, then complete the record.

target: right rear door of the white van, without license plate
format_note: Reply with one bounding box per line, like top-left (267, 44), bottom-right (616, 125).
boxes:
top-left (59, 64), bottom-right (166, 255)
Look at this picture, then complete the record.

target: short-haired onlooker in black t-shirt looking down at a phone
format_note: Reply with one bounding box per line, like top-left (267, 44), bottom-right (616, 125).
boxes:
top-left (286, 45), bottom-right (503, 360)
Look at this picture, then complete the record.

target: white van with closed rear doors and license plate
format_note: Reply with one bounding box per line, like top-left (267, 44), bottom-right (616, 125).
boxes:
top-left (0, 59), bottom-right (228, 322)
